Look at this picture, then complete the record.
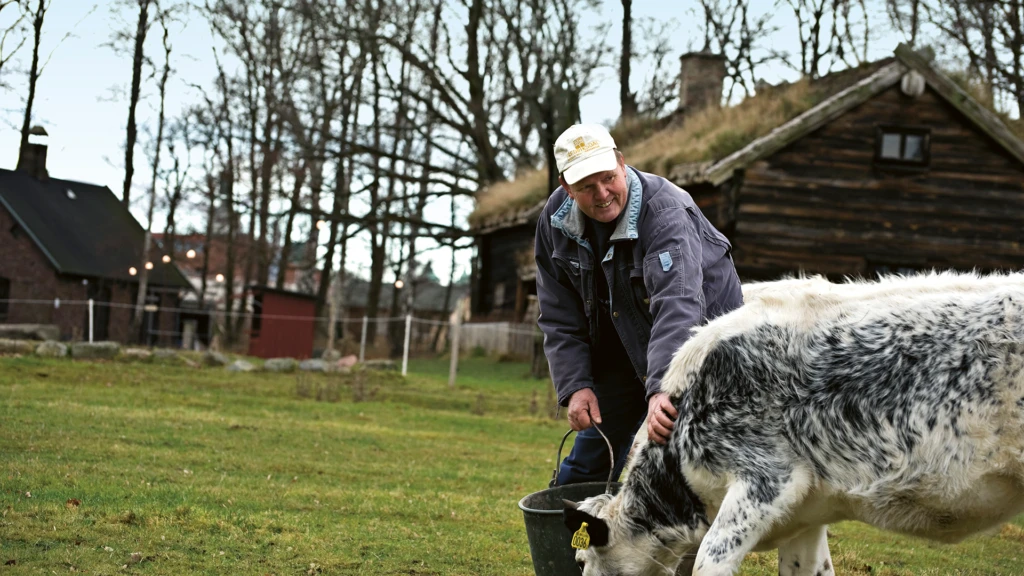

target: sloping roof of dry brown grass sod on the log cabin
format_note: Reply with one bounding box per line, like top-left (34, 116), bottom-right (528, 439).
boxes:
top-left (469, 58), bottom-right (893, 230)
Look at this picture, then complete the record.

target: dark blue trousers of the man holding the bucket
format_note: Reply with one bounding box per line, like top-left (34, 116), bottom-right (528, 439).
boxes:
top-left (557, 380), bottom-right (647, 486)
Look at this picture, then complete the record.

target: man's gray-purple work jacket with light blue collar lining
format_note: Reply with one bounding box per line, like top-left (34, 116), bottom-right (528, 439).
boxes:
top-left (535, 167), bottom-right (742, 406)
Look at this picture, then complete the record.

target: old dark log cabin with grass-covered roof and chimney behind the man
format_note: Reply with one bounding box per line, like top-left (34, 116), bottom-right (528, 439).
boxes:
top-left (470, 45), bottom-right (1024, 322)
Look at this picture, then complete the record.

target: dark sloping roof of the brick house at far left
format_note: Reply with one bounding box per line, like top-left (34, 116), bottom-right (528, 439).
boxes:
top-left (0, 169), bottom-right (191, 289)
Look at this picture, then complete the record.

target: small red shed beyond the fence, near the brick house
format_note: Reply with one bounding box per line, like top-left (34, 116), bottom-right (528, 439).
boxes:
top-left (249, 286), bottom-right (316, 359)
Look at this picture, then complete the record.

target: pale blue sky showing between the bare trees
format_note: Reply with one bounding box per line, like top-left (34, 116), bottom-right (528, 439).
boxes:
top-left (0, 0), bottom-right (913, 278)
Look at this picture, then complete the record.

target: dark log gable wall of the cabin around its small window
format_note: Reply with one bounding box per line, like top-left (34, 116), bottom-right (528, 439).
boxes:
top-left (733, 86), bottom-right (1024, 279)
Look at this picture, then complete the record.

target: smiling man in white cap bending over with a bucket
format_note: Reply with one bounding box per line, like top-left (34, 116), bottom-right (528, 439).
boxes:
top-left (536, 124), bottom-right (742, 485)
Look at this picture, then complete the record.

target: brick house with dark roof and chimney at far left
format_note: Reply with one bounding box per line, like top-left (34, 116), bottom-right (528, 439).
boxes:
top-left (0, 128), bottom-right (190, 345)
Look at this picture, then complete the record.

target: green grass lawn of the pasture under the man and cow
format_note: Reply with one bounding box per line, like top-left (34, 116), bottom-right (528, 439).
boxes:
top-left (0, 358), bottom-right (1024, 575)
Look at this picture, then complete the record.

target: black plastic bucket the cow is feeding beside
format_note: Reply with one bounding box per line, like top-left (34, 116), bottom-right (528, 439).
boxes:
top-left (519, 475), bottom-right (623, 576)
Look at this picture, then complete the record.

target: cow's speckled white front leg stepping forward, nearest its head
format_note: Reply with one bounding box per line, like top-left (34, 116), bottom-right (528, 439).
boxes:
top-left (693, 472), bottom-right (802, 576)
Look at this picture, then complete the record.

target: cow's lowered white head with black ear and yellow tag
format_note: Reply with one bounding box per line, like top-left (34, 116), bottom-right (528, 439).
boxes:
top-left (562, 492), bottom-right (708, 576)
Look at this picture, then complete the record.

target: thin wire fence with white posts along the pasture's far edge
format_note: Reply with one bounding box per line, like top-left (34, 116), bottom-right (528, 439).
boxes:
top-left (0, 298), bottom-right (546, 382)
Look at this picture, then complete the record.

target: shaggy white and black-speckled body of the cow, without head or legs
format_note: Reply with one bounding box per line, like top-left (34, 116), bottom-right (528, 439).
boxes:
top-left (670, 276), bottom-right (1024, 540)
